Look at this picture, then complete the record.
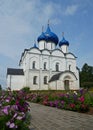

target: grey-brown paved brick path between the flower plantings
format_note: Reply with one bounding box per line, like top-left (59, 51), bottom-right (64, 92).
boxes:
top-left (30, 103), bottom-right (93, 130)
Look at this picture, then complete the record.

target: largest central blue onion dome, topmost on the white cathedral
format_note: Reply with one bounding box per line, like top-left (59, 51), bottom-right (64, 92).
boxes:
top-left (44, 24), bottom-right (59, 45)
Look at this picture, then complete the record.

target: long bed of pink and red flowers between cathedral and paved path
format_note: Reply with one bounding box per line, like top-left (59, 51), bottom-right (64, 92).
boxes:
top-left (28, 89), bottom-right (93, 112)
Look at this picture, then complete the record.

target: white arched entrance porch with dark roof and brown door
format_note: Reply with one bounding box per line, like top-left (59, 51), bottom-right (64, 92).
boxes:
top-left (49, 71), bottom-right (77, 90)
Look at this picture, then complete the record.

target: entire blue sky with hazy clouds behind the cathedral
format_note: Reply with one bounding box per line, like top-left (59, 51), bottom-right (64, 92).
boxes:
top-left (0, 0), bottom-right (93, 88)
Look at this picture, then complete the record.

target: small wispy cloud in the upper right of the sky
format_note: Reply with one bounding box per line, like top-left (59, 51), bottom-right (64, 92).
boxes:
top-left (64, 5), bottom-right (78, 15)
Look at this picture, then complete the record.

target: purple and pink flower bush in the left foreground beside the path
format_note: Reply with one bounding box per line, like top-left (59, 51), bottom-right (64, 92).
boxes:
top-left (0, 89), bottom-right (30, 130)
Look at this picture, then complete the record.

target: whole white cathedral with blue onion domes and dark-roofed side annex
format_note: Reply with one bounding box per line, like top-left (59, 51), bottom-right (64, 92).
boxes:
top-left (7, 24), bottom-right (79, 90)
